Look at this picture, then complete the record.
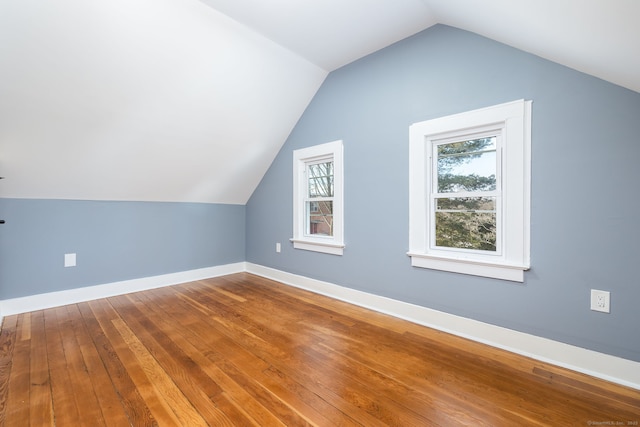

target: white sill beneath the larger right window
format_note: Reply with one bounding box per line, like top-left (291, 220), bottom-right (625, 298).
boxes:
top-left (407, 252), bottom-right (529, 282)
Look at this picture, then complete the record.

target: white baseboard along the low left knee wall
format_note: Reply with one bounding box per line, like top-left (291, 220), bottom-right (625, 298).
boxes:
top-left (0, 262), bottom-right (246, 319)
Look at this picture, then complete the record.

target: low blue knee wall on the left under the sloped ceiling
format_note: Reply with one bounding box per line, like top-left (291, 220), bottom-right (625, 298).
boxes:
top-left (0, 199), bottom-right (245, 299)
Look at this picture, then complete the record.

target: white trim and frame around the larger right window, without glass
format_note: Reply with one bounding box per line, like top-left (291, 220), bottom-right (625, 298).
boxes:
top-left (408, 100), bottom-right (531, 282)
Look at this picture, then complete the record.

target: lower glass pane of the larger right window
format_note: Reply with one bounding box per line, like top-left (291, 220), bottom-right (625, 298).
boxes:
top-left (435, 197), bottom-right (496, 252)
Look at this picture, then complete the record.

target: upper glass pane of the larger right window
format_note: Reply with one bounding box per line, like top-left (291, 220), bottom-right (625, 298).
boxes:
top-left (437, 136), bottom-right (497, 193)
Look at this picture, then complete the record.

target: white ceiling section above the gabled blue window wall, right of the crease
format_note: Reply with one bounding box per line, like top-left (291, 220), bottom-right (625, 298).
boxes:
top-left (201, 0), bottom-right (640, 92)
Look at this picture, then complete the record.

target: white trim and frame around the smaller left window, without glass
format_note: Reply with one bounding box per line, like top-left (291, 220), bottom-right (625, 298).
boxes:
top-left (291, 140), bottom-right (345, 255)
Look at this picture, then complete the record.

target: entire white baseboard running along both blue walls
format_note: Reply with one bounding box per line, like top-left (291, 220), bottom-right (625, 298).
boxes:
top-left (0, 262), bottom-right (640, 390)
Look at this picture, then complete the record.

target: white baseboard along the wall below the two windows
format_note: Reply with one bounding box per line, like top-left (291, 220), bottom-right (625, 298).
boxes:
top-left (246, 263), bottom-right (640, 390)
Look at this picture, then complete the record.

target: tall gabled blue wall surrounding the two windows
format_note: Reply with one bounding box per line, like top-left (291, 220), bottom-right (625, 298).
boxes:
top-left (247, 25), bottom-right (640, 361)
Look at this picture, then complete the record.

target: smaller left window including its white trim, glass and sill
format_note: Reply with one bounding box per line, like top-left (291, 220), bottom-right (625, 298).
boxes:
top-left (291, 141), bottom-right (344, 255)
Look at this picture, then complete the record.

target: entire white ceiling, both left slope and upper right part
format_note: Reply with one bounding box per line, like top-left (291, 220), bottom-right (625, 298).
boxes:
top-left (0, 0), bottom-right (640, 204)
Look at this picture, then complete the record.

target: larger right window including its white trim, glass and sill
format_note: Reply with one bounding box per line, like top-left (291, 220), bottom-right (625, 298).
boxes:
top-left (409, 101), bottom-right (531, 282)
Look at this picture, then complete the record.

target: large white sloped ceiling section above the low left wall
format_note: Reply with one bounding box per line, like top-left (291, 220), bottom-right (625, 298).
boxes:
top-left (0, 0), bottom-right (327, 204)
